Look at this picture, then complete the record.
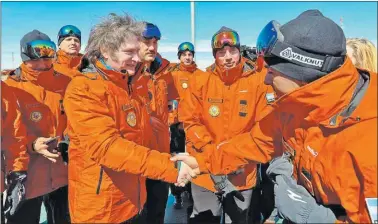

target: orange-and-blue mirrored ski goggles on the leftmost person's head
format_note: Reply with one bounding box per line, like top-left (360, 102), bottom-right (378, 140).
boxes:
top-left (21, 40), bottom-right (56, 60)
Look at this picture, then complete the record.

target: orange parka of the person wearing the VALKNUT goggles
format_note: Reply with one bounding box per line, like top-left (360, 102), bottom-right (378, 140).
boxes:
top-left (194, 58), bottom-right (377, 223)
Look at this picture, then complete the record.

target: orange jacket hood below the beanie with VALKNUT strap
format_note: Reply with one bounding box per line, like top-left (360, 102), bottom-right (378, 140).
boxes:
top-left (273, 58), bottom-right (377, 128)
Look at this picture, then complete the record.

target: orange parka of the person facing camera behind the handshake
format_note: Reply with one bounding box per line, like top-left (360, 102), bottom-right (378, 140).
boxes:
top-left (182, 58), bottom-right (273, 192)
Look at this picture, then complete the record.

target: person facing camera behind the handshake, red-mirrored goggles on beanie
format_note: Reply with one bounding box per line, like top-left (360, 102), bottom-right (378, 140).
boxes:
top-left (181, 27), bottom-right (274, 223)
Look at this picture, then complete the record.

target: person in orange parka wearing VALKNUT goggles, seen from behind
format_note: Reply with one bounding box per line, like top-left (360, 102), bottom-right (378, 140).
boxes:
top-left (173, 10), bottom-right (377, 223)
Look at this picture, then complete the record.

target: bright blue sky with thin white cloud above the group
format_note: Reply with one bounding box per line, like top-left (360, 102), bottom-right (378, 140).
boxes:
top-left (1, 2), bottom-right (378, 69)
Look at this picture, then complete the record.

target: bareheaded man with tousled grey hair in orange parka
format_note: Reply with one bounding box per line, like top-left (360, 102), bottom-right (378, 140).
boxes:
top-left (64, 13), bottom-right (195, 223)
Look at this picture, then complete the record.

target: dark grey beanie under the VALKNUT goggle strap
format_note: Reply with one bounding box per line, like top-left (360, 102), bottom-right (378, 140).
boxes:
top-left (265, 10), bottom-right (346, 83)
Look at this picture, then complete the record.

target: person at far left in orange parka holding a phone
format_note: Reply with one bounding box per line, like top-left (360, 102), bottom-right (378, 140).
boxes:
top-left (5, 30), bottom-right (69, 223)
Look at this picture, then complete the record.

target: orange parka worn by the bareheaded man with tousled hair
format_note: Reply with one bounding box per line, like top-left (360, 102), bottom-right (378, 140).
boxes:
top-left (64, 61), bottom-right (178, 223)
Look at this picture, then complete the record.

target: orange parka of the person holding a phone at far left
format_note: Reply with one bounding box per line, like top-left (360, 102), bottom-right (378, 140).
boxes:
top-left (5, 64), bottom-right (68, 199)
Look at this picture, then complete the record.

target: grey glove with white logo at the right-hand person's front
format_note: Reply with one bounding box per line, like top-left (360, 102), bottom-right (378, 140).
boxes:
top-left (274, 172), bottom-right (336, 223)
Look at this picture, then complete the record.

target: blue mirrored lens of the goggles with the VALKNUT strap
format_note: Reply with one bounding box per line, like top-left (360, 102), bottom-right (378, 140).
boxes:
top-left (256, 20), bottom-right (280, 57)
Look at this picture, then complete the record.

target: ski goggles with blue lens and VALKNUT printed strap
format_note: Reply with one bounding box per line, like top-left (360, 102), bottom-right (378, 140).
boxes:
top-left (256, 20), bottom-right (344, 72)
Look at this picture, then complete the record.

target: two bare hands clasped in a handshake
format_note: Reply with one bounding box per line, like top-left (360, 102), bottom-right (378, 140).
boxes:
top-left (171, 153), bottom-right (200, 187)
